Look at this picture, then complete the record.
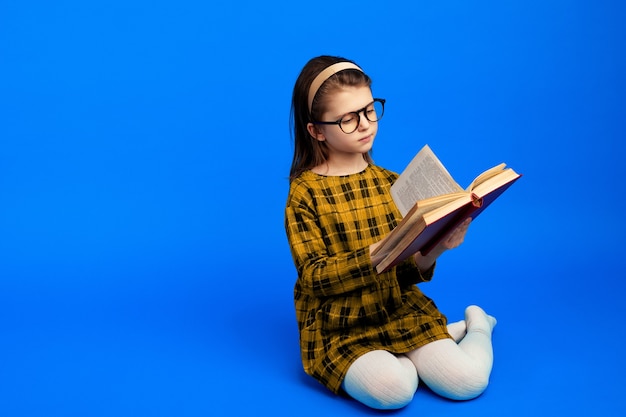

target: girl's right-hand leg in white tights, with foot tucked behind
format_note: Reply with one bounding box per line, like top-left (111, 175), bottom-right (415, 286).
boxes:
top-left (407, 306), bottom-right (496, 400)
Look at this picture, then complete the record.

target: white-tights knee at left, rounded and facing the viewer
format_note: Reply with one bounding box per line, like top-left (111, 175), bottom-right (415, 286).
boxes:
top-left (342, 350), bottom-right (418, 410)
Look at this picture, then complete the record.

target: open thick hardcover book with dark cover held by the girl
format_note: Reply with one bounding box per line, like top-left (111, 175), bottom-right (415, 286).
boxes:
top-left (372, 145), bottom-right (521, 273)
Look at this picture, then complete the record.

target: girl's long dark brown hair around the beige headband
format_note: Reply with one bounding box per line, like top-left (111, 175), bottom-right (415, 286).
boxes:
top-left (289, 55), bottom-right (372, 181)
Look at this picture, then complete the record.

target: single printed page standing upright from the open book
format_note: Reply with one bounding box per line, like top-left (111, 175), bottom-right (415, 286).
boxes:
top-left (391, 145), bottom-right (463, 216)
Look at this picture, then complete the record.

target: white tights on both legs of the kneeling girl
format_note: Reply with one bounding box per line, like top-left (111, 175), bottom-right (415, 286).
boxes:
top-left (342, 306), bottom-right (496, 409)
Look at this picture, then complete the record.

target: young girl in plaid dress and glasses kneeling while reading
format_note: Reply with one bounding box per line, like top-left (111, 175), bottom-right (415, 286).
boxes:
top-left (285, 56), bottom-right (496, 409)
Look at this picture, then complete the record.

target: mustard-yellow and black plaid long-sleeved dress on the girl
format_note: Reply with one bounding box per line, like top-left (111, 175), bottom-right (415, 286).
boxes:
top-left (285, 165), bottom-right (450, 393)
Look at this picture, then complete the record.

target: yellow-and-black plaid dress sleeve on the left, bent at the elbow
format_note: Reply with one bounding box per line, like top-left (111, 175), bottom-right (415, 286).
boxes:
top-left (285, 187), bottom-right (388, 297)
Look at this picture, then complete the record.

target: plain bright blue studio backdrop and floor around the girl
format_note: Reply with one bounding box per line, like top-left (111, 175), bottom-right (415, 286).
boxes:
top-left (0, 0), bottom-right (626, 416)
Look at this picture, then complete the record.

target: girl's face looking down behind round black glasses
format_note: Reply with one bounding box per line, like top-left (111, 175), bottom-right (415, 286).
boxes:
top-left (307, 86), bottom-right (378, 158)
